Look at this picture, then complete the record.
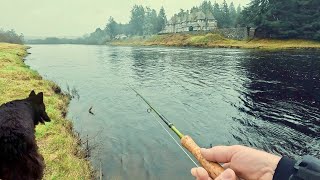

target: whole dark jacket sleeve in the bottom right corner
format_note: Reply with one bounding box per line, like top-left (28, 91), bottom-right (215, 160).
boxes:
top-left (273, 155), bottom-right (320, 180)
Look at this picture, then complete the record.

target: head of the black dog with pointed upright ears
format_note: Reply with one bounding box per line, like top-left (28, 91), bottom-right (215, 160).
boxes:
top-left (28, 91), bottom-right (51, 125)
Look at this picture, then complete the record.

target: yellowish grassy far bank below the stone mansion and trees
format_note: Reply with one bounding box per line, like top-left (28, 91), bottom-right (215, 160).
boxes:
top-left (111, 33), bottom-right (320, 49)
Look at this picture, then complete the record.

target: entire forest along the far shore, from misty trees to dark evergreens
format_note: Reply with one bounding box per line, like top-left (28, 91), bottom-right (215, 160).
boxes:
top-left (21, 0), bottom-right (320, 44)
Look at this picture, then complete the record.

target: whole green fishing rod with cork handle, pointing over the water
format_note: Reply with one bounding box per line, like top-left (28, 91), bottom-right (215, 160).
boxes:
top-left (130, 87), bottom-right (224, 179)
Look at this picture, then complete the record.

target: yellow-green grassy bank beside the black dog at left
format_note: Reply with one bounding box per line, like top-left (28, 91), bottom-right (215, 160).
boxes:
top-left (0, 43), bottom-right (92, 180)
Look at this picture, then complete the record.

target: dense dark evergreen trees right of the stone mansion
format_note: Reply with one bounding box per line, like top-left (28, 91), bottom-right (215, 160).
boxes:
top-left (242, 0), bottom-right (320, 40)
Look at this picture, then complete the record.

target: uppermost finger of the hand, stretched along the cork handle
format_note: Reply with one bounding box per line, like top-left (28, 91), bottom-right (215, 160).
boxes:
top-left (201, 146), bottom-right (239, 163)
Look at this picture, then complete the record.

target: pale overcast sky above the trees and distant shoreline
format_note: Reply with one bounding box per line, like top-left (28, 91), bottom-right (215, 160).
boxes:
top-left (0, 0), bottom-right (250, 37)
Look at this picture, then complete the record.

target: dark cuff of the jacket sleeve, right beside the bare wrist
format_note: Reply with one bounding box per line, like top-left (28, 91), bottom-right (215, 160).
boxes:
top-left (273, 157), bottom-right (296, 180)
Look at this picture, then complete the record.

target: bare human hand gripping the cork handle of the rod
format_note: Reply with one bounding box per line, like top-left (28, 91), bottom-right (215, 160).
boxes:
top-left (191, 145), bottom-right (281, 180)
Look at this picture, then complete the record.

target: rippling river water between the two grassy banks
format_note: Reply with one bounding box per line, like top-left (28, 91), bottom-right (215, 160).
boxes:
top-left (26, 45), bottom-right (320, 180)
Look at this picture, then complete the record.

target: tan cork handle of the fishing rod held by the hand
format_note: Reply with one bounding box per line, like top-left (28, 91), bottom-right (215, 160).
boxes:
top-left (181, 135), bottom-right (224, 179)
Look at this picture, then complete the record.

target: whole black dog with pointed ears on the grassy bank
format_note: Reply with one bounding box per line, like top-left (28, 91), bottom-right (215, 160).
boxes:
top-left (0, 91), bottom-right (50, 180)
